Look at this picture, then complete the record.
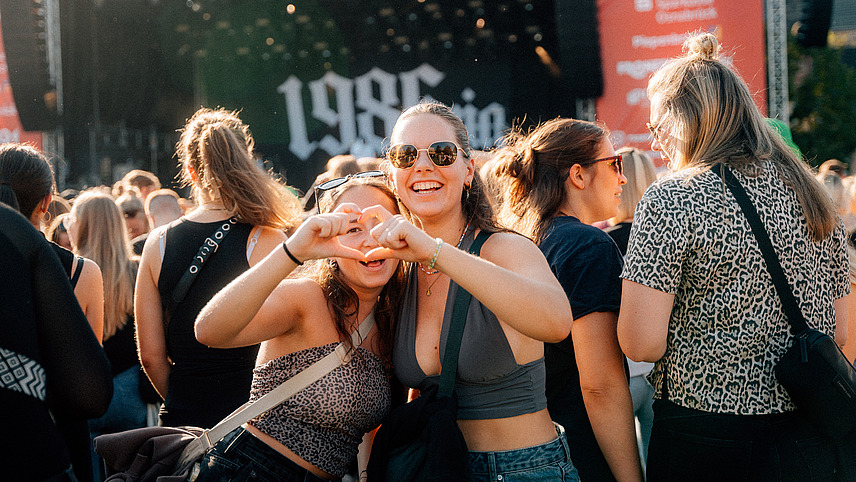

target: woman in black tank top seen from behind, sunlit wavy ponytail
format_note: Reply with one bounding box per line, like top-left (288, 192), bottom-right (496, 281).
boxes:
top-left (135, 108), bottom-right (300, 427)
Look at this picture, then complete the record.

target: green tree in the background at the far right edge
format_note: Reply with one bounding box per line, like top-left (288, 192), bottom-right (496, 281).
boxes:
top-left (788, 38), bottom-right (856, 166)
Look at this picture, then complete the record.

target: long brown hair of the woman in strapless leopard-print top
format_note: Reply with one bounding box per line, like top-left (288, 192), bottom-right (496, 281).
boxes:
top-left (308, 177), bottom-right (405, 366)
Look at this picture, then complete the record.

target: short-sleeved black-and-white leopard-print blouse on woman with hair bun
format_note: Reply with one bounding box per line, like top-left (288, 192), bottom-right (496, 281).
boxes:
top-left (621, 162), bottom-right (850, 415)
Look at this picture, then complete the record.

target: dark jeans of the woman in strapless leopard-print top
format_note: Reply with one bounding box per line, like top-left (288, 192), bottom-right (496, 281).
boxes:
top-left (188, 428), bottom-right (325, 482)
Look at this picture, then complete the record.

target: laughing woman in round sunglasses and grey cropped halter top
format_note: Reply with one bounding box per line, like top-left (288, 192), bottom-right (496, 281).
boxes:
top-left (363, 103), bottom-right (577, 481)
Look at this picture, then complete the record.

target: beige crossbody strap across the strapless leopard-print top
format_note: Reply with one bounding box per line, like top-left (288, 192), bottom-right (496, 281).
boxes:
top-left (178, 310), bottom-right (375, 466)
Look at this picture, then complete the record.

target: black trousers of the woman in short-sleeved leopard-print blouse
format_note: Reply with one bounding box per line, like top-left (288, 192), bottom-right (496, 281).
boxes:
top-left (647, 400), bottom-right (844, 482)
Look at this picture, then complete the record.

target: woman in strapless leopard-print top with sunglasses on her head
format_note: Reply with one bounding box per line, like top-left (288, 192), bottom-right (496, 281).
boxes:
top-left (196, 177), bottom-right (403, 481)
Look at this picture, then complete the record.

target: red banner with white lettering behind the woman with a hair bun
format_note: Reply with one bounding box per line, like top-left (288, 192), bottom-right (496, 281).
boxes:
top-left (595, 0), bottom-right (767, 164)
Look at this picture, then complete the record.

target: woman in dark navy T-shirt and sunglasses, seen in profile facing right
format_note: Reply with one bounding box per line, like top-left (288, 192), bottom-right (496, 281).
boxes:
top-left (488, 118), bottom-right (642, 481)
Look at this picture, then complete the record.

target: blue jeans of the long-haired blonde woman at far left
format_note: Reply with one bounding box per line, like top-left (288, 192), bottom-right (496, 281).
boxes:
top-left (89, 365), bottom-right (148, 482)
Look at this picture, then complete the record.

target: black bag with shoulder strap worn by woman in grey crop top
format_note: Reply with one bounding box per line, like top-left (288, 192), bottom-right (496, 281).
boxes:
top-left (367, 232), bottom-right (490, 482)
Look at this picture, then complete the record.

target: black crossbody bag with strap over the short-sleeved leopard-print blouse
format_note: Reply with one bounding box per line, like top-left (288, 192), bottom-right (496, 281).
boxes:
top-left (713, 164), bottom-right (856, 440)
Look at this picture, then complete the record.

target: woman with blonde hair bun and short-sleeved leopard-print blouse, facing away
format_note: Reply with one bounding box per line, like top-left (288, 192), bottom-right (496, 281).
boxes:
top-left (618, 33), bottom-right (856, 481)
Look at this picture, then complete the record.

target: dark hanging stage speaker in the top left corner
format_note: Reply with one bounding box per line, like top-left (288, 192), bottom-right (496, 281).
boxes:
top-left (0, 0), bottom-right (58, 131)
